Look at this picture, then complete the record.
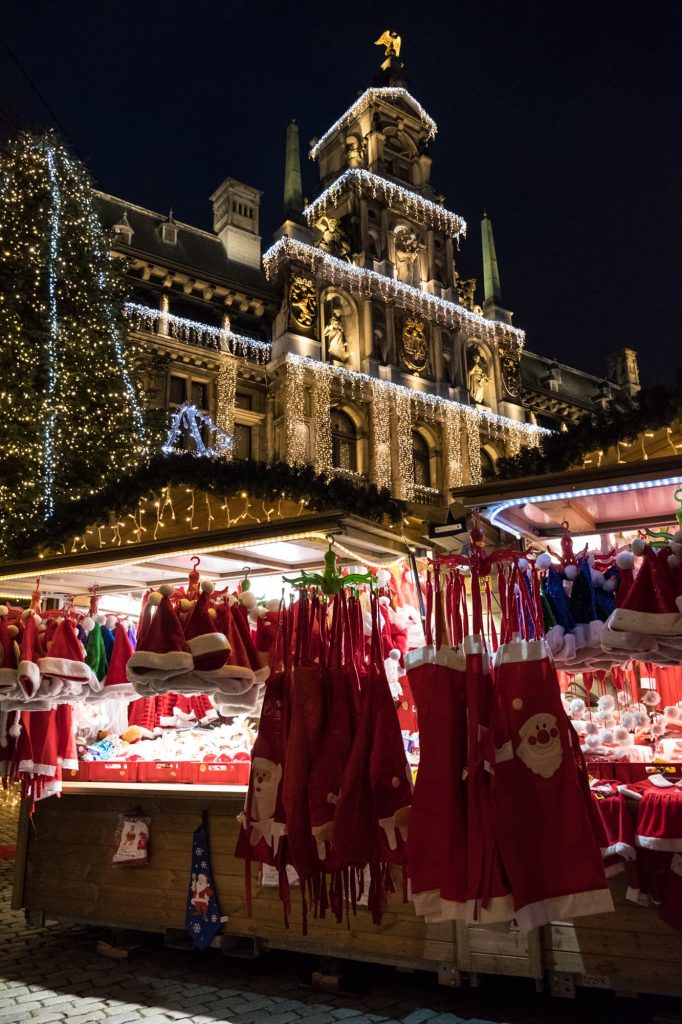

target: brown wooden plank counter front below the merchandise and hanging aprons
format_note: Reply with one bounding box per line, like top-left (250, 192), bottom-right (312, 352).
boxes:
top-left (13, 782), bottom-right (682, 995)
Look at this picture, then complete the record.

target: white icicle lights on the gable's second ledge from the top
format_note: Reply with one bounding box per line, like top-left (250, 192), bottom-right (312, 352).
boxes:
top-left (303, 167), bottom-right (467, 238)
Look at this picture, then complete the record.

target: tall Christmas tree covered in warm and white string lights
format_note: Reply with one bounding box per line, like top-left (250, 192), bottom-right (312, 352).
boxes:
top-left (0, 133), bottom-right (145, 545)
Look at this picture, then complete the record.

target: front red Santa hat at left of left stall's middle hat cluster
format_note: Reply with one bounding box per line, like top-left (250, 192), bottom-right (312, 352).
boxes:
top-left (126, 584), bottom-right (193, 683)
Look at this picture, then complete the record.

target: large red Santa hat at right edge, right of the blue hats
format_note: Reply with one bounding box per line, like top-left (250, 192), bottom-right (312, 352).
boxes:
top-left (608, 541), bottom-right (682, 636)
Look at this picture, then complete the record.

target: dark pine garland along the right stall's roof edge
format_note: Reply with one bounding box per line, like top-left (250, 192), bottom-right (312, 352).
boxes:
top-left (492, 371), bottom-right (682, 480)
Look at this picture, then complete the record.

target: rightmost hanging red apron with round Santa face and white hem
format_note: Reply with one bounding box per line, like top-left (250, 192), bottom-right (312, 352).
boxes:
top-left (488, 640), bottom-right (613, 932)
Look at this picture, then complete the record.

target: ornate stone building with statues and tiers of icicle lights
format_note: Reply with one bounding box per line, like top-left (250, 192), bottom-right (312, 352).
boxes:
top-left (98, 37), bottom-right (638, 512)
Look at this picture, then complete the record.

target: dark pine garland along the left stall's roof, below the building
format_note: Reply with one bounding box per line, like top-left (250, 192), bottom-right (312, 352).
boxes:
top-left (6, 454), bottom-right (406, 559)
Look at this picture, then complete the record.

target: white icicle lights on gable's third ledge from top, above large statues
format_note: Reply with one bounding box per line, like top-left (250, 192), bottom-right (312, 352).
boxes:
top-left (263, 238), bottom-right (525, 348)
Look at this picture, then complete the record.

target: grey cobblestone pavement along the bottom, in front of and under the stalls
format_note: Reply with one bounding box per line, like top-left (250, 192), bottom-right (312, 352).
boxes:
top-left (0, 811), bottom-right (682, 1024)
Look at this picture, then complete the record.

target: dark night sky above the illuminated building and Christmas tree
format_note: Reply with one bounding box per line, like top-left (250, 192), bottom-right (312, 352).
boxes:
top-left (0, 0), bottom-right (682, 381)
